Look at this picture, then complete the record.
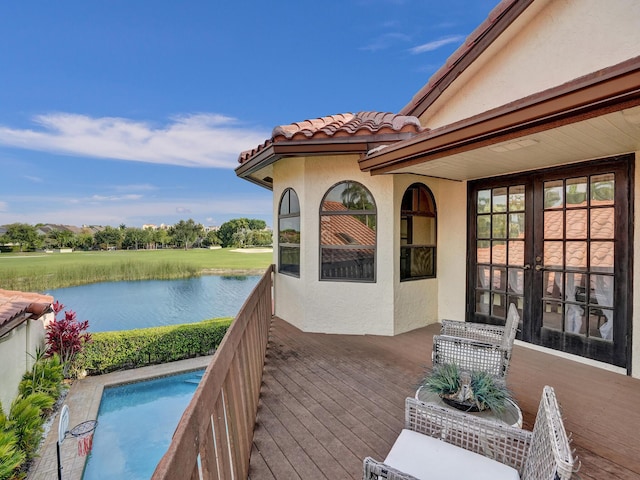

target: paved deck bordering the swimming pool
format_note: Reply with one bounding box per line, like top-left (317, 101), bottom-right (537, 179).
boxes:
top-left (27, 356), bottom-right (212, 480)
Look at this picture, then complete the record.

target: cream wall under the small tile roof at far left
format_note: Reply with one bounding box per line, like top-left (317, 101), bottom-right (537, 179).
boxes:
top-left (0, 313), bottom-right (54, 414)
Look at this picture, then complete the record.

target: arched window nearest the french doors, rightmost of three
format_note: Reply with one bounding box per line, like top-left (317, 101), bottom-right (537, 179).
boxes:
top-left (400, 183), bottom-right (437, 281)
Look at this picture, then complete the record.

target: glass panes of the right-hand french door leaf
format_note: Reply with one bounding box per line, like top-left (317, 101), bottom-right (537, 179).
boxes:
top-left (536, 175), bottom-right (615, 345)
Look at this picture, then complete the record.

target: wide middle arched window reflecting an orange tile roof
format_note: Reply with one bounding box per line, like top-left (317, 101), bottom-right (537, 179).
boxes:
top-left (320, 181), bottom-right (376, 282)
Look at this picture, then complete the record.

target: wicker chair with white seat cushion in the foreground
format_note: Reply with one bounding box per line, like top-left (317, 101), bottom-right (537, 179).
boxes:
top-left (363, 386), bottom-right (575, 480)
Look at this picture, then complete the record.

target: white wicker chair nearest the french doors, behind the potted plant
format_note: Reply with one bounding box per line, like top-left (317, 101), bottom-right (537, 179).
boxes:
top-left (432, 303), bottom-right (520, 378)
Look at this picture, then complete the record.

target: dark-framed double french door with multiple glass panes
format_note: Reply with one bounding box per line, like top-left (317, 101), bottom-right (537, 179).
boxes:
top-left (467, 156), bottom-right (634, 367)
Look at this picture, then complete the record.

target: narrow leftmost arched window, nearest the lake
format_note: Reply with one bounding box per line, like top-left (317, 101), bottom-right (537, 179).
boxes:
top-left (278, 188), bottom-right (300, 277)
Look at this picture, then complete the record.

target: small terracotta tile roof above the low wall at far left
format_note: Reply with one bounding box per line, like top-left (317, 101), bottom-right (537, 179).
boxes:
top-left (0, 289), bottom-right (53, 336)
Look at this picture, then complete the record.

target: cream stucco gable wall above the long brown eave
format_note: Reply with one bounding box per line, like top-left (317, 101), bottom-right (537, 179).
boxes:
top-left (421, 0), bottom-right (640, 128)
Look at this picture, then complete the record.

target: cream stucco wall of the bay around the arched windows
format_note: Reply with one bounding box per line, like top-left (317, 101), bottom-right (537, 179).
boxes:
top-left (273, 156), bottom-right (466, 335)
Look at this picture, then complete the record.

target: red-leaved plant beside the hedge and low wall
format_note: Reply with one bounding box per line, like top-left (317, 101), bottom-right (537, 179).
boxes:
top-left (47, 301), bottom-right (91, 378)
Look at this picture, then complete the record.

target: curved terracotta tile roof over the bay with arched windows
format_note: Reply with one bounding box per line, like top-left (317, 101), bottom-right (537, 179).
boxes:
top-left (238, 112), bottom-right (424, 164)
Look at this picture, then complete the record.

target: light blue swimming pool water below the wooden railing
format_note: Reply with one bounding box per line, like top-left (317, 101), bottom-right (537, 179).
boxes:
top-left (82, 370), bottom-right (204, 480)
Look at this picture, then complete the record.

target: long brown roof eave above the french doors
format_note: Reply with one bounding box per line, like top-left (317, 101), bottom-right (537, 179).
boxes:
top-left (359, 57), bottom-right (640, 174)
